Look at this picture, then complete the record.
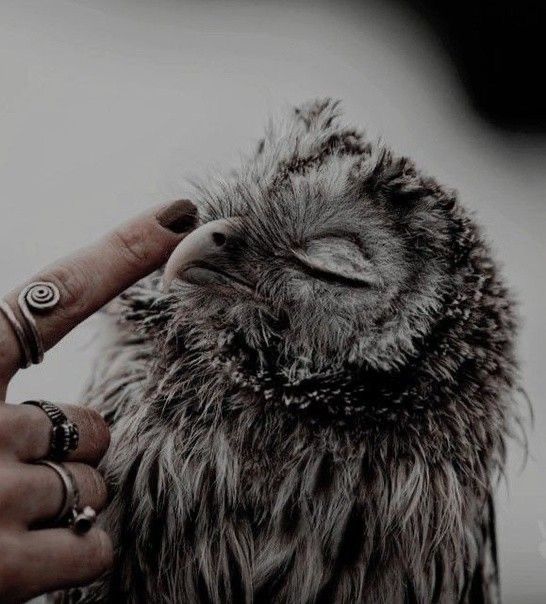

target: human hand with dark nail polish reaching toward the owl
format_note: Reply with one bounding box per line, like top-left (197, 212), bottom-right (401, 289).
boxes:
top-left (0, 200), bottom-right (197, 602)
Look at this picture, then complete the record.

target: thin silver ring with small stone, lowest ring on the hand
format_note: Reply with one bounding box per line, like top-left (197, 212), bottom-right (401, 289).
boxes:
top-left (36, 459), bottom-right (97, 535)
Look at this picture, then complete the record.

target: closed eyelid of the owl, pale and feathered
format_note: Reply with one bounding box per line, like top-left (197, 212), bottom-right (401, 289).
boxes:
top-left (292, 237), bottom-right (380, 287)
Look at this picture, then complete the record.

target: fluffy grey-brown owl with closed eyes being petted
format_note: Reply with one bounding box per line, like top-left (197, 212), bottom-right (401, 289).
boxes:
top-left (72, 100), bottom-right (518, 604)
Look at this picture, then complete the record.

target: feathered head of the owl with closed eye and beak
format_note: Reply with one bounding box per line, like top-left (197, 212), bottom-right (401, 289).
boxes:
top-left (158, 100), bottom-right (464, 378)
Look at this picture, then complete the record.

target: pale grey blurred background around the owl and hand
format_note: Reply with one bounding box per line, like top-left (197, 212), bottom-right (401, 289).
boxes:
top-left (0, 0), bottom-right (546, 603)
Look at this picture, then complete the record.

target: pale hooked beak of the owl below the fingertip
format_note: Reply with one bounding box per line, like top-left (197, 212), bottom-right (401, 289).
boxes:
top-left (163, 218), bottom-right (244, 292)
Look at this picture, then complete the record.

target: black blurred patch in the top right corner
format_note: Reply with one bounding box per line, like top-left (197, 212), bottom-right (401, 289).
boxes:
top-left (401, 0), bottom-right (546, 133)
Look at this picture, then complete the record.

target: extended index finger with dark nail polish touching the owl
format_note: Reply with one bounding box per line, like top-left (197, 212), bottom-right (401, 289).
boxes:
top-left (0, 200), bottom-right (198, 381)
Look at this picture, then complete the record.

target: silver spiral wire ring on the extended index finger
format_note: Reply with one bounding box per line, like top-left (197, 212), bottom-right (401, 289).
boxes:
top-left (0, 281), bottom-right (61, 367)
